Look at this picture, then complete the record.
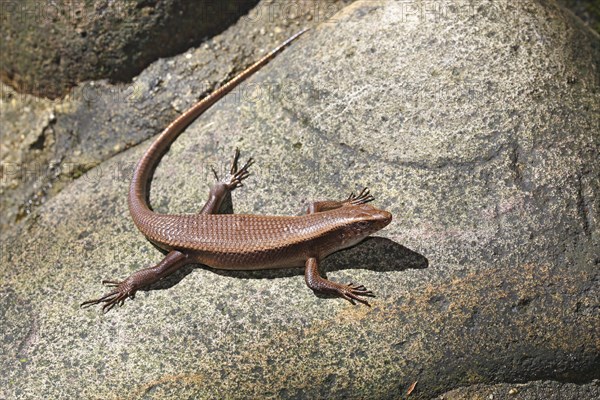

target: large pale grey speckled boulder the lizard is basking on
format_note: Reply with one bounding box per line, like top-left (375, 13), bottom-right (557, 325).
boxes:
top-left (0, 1), bottom-right (600, 399)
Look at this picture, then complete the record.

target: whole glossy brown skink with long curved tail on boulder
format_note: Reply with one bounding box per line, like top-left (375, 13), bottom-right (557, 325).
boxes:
top-left (81, 30), bottom-right (392, 312)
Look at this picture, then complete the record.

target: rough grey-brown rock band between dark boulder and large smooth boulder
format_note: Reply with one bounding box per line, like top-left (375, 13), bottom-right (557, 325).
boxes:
top-left (0, 0), bottom-right (350, 234)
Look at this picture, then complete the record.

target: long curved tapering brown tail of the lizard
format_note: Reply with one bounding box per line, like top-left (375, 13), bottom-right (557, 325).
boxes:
top-left (128, 29), bottom-right (308, 228)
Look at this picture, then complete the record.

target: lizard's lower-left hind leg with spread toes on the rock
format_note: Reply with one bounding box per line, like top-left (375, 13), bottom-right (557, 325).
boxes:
top-left (81, 250), bottom-right (187, 313)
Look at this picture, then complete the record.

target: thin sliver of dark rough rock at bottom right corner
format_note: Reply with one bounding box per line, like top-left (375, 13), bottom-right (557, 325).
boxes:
top-left (436, 380), bottom-right (600, 400)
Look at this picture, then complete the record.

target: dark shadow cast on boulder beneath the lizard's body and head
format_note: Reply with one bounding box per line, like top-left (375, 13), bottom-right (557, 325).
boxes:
top-left (142, 236), bottom-right (429, 297)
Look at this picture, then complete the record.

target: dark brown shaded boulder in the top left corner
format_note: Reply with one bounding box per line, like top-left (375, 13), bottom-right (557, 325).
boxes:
top-left (0, 0), bottom-right (258, 98)
